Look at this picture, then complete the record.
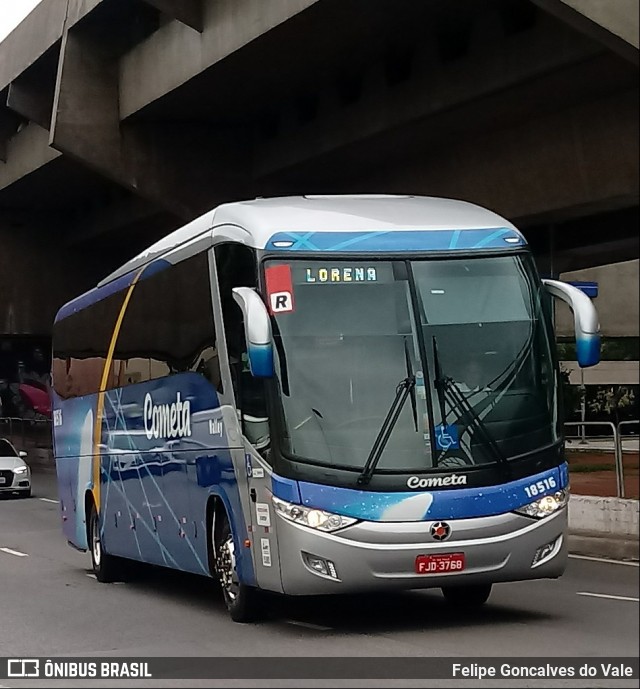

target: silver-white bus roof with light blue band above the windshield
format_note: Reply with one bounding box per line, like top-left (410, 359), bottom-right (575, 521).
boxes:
top-left (56, 194), bottom-right (526, 320)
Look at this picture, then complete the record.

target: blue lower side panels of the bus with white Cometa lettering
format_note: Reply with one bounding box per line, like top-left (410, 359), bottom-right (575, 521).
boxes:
top-left (55, 372), bottom-right (254, 583)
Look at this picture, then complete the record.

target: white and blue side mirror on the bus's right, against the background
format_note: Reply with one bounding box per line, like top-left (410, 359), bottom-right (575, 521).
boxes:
top-left (542, 280), bottom-right (600, 368)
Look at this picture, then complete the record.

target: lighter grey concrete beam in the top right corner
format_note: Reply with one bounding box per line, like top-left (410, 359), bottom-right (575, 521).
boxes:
top-left (533, 0), bottom-right (639, 65)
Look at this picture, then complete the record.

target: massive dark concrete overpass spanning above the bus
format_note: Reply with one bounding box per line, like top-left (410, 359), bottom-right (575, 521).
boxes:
top-left (0, 0), bottom-right (640, 335)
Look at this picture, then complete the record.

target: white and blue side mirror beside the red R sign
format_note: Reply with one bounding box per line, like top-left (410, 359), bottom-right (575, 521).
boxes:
top-left (232, 287), bottom-right (273, 378)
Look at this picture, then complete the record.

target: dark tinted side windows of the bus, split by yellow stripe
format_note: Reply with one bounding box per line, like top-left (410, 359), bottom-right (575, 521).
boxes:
top-left (53, 254), bottom-right (221, 398)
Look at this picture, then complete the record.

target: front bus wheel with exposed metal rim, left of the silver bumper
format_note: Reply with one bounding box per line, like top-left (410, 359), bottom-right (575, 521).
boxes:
top-left (215, 514), bottom-right (260, 622)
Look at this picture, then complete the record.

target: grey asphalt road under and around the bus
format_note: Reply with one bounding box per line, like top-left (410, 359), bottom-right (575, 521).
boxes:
top-left (0, 473), bottom-right (639, 687)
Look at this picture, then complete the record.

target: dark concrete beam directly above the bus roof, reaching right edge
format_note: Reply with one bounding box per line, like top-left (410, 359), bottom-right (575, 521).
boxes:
top-left (362, 88), bottom-right (640, 223)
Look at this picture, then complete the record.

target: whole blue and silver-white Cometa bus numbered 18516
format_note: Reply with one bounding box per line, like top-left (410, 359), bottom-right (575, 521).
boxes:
top-left (53, 196), bottom-right (599, 621)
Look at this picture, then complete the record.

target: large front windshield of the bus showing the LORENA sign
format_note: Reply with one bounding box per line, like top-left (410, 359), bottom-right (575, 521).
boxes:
top-left (265, 255), bottom-right (558, 473)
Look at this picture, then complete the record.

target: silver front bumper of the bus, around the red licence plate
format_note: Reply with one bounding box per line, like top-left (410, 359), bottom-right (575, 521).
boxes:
top-left (277, 507), bottom-right (567, 595)
